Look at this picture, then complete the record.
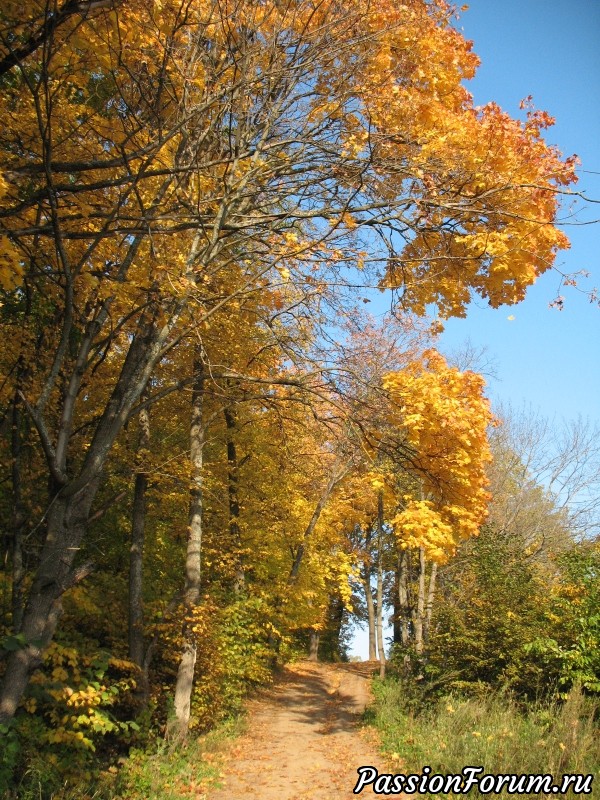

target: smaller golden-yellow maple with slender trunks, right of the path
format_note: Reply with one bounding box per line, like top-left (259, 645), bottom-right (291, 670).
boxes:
top-left (344, 349), bottom-right (493, 659)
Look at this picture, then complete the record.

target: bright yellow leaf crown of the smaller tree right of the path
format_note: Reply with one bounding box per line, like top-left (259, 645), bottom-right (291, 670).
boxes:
top-left (384, 350), bottom-right (492, 562)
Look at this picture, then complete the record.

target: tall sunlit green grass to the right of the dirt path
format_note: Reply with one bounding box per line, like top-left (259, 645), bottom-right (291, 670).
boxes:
top-left (370, 679), bottom-right (600, 798)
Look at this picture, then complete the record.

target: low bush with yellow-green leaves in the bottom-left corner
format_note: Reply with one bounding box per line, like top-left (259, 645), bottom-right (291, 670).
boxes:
top-left (0, 637), bottom-right (139, 796)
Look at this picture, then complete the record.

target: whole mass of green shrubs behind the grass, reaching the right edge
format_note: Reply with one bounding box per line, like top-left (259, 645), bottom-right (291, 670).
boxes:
top-left (425, 526), bottom-right (600, 699)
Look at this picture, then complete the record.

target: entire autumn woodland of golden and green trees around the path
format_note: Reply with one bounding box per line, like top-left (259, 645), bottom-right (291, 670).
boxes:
top-left (0, 0), bottom-right (600, 797)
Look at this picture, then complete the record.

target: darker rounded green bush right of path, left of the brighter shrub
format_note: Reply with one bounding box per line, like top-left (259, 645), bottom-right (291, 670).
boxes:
top-left (426, 526), bottom-right (557, 698)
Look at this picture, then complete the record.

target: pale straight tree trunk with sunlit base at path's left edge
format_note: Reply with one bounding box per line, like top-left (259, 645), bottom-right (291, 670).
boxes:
top-left (168, 354), bottom-right (205, 741)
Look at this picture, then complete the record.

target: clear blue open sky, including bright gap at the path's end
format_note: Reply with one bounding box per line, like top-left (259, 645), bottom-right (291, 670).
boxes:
top-left (352, 0), bottom-right (600, 658)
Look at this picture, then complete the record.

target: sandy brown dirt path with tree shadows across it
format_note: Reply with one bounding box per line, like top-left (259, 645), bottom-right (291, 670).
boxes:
top-left (208, 662), bottom-right (386, 800)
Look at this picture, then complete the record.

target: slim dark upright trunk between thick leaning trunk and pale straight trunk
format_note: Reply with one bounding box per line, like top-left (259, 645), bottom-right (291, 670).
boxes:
top-left (129, 408), bottom-right (150, 672)
